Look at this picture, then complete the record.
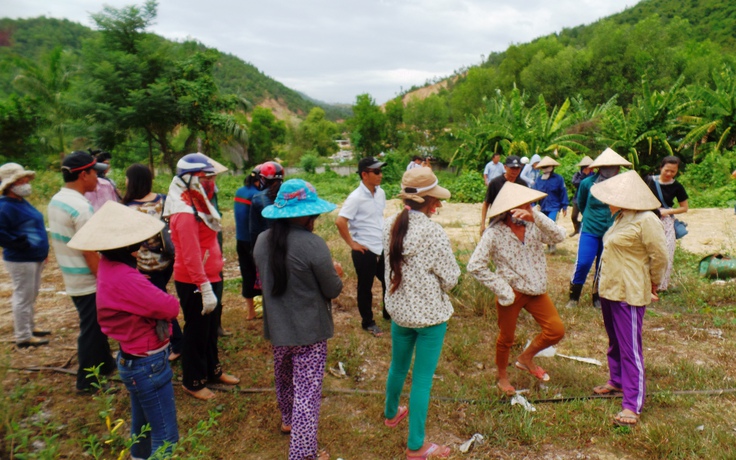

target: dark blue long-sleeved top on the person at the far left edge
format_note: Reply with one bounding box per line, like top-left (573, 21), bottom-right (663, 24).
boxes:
top-left (0, 196), bottom-right (49, 262)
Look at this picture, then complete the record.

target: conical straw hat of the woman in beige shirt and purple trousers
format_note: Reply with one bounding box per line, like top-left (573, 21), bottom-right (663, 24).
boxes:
top-left (590, 171), bottom-right (661, 211)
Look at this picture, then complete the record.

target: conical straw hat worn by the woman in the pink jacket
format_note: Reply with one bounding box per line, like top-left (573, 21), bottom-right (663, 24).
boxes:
top-left (67, 201), bottom-right (164, 251)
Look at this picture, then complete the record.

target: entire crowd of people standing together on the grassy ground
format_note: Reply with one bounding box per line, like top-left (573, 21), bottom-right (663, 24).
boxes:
top-left (0, 149), bottom-right (687, 459)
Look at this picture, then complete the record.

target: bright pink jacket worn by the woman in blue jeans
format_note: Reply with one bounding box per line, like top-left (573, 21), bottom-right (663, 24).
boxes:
top-left (97, 256), bottom-right (179, 355)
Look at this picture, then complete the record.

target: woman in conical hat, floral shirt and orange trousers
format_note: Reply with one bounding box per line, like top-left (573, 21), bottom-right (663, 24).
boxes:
top-left (468, 182), bottom-right (565, 395)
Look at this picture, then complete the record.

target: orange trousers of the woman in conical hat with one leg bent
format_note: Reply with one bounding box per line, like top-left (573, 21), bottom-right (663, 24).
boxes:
top-left (496, 291), bottom-right (565, 370)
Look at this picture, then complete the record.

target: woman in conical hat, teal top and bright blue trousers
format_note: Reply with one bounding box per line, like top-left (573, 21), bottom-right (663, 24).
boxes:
top-left (566, 148), bottom-right (631, 308)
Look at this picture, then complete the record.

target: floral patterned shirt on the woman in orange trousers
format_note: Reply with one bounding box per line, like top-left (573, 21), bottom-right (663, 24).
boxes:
top-left (468, 211), bottom-right (565, 306)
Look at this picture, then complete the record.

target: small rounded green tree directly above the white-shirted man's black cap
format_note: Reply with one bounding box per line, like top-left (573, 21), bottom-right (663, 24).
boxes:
top-left (352, 94), bottom-right (386, 157)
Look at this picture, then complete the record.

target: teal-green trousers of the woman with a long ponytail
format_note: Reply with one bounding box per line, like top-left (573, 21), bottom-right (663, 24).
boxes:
top-left (384, 322), bottom-right (447, 450)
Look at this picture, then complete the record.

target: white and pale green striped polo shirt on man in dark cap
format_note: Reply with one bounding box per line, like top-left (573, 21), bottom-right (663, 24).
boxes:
top-left (48, 187), bottom-right (97, 296)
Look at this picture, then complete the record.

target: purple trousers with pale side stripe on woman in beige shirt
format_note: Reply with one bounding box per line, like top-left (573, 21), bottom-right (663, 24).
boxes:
top-left (601, 297), bottom-right (646, 414)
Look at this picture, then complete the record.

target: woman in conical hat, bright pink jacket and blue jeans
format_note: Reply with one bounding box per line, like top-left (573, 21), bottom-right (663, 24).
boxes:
top-left (67, 201), bottom-right (179, 458)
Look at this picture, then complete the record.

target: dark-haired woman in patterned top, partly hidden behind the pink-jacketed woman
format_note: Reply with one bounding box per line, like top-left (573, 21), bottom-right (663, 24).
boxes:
top-left (123, 163), bottom-right (182, 361)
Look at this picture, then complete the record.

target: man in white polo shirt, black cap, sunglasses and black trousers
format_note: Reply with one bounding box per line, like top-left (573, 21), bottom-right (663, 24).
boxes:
top-left (335, 157), bottom-right (390, 337)
